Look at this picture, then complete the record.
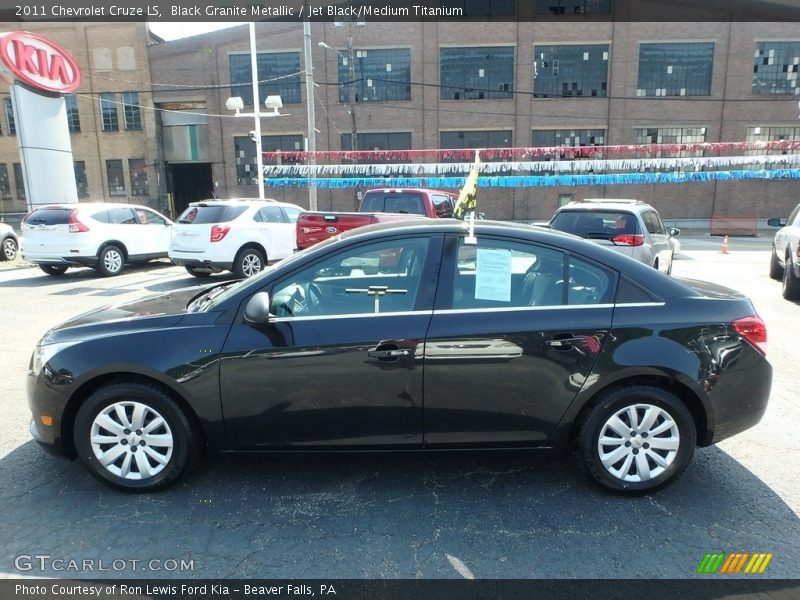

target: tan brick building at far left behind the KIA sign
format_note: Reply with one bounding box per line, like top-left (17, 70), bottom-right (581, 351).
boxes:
top-left (0, 23), bottom-right (159, 220)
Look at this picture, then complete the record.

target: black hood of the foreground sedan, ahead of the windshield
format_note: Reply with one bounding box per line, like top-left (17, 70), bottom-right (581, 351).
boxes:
top-left (41, 287), bottom-right (203, 344)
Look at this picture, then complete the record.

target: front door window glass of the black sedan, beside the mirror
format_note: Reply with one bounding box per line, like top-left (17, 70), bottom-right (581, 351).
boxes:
top-left (270, 238), bottom-right (430, 317)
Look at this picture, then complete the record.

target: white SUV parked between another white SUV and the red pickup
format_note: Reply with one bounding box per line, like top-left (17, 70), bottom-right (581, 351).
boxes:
top-left (169, 200), bottom-right (303, 277)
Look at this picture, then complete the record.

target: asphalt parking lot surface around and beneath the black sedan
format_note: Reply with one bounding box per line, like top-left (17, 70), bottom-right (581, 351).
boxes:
top-left (0, 238), bottom-right (800, 578)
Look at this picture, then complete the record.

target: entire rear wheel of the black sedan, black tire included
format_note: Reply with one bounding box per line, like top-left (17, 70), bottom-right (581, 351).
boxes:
top-left (577, 385), bottom-right (697, 495)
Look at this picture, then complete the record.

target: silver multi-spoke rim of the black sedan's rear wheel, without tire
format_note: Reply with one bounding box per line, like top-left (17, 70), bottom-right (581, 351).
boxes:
top-left (597, 404), bottom-right (681, 482)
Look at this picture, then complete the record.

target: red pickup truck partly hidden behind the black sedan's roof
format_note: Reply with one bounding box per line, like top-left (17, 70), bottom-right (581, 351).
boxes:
top-left (297, 188), bottom-right (458, 250)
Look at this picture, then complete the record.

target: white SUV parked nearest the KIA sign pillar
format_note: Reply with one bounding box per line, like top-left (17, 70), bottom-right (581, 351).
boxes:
top-left (21, 202), bottom-right (172, 277)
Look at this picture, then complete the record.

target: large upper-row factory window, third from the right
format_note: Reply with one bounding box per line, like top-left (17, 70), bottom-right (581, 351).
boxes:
top-left (533, 44), bottom-right (608, 98)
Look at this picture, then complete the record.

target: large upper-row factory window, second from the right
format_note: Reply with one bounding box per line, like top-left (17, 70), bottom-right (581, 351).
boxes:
top-left (636, 42), bottom-right (714, 96)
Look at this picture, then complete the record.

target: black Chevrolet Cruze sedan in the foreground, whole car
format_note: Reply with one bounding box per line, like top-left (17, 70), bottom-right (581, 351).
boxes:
top-left (28, 220), bottom-right (772, 493)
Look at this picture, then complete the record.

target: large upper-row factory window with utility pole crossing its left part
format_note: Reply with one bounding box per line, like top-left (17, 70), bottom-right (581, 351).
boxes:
top-left (338, 48), bottom-right (411, 102)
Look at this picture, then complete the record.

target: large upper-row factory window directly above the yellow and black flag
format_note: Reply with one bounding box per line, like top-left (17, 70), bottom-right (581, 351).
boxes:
top-left (439, 46), bottom-right (514, 100)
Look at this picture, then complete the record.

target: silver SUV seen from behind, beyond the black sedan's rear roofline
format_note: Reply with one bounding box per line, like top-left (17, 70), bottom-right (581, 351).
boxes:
top-left (548, 198), bottom-right (681, 274)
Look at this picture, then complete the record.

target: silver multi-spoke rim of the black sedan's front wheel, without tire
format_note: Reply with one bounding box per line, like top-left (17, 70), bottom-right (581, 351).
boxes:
top-left (90, 401), bottom-right (175, 480)
